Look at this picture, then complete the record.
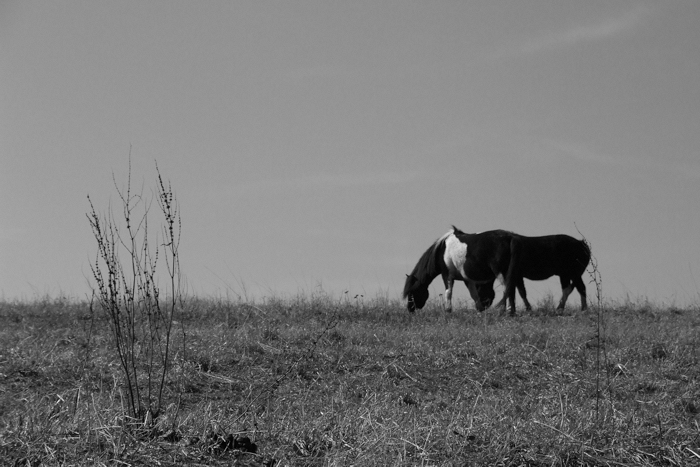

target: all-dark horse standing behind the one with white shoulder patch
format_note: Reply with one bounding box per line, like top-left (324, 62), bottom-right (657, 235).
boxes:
top-left (496, 233), bottom-right (591, 315)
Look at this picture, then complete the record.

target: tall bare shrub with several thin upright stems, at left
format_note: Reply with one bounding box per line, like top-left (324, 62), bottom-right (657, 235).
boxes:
top-left (87, 160), bottom-right (183, 423)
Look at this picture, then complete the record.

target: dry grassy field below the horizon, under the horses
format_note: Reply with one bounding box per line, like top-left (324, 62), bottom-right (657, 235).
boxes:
top-left (0, 293), bottom-right (700, 466)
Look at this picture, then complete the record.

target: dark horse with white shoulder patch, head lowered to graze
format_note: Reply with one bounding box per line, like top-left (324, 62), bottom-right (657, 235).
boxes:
top-left (403, 226), bottom-right (510, 313)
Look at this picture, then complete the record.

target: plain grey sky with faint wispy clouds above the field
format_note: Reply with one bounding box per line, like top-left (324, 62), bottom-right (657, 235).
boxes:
top-left (0, 0), bottom-right (700, 306)
